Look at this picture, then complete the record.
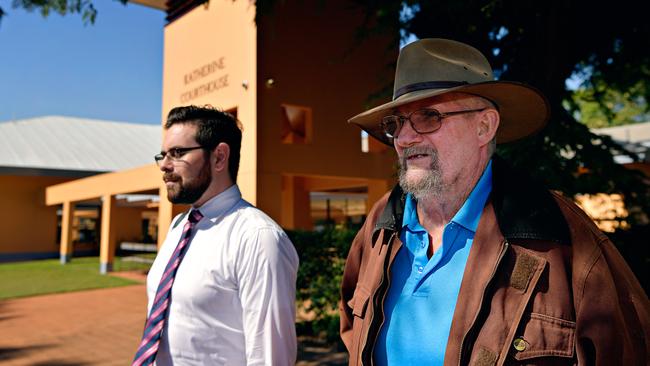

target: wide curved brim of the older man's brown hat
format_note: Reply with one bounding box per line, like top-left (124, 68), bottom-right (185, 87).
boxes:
top-left (348, 81), bottom-right (551, 146)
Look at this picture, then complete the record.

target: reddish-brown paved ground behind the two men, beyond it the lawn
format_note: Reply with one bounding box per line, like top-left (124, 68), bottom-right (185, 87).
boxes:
top-left (0, 274), bottom-right (345, 366)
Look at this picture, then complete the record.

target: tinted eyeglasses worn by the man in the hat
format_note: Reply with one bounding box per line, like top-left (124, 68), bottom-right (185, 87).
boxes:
top-left (379, 108), bottom-right (487, 139)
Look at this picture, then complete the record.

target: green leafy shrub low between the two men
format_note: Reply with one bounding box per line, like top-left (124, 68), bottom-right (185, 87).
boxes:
top-left (287, 228), bottom-right (356, 341)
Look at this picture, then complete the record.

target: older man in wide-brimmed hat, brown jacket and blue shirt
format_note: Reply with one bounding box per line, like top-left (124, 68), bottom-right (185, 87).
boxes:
top-left (340, 39), bottom-right (650, 366)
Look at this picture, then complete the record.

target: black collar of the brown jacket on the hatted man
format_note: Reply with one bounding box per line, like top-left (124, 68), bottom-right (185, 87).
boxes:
top-left (373, 156), bottom-right (571, 244)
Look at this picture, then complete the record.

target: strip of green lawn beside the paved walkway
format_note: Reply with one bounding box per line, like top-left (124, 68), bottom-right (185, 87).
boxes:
top-left (0, 257), bottom-right (151, 300)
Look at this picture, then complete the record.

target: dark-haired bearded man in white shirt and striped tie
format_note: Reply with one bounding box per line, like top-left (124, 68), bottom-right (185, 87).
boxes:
top-left (133, 106), bottom-right (298, 366)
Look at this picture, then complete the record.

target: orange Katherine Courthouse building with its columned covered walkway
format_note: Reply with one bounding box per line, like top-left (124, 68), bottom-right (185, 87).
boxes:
top-left (45, 0), bottom-right (398, 272)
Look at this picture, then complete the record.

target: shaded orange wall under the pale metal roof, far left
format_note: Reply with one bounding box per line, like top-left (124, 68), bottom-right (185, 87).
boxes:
top-left (0, 175), bottom-right (70, 254)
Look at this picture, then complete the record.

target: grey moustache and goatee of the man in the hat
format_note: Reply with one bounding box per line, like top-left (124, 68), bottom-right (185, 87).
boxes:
top-left (399, 146), bottom-right (443, 200)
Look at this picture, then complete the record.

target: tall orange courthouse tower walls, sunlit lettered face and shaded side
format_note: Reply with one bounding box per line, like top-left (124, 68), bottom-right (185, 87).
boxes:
top-left (162, 0), bottom-right (398, 224)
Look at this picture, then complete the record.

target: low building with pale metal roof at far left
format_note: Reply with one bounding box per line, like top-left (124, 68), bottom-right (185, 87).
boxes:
top-left (0, 116), bottom-right (161, 262)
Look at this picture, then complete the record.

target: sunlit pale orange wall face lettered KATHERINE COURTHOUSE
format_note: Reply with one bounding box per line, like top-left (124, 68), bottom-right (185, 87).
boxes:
top-left (162, 0), bottom-right (257, 204)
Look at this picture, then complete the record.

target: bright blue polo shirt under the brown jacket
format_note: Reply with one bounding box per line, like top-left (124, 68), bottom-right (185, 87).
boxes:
top-left (374, 161), bottom-right (492, 366)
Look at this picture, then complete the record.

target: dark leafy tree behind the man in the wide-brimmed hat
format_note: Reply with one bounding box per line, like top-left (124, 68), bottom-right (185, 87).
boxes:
top-left (346, 0), bottom-right (650, 223)
